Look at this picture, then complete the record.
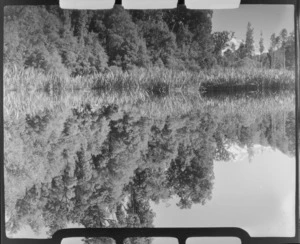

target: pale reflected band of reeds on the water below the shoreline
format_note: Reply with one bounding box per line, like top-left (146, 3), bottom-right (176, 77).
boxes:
top-left (4, 89), bottom-right (295, 123)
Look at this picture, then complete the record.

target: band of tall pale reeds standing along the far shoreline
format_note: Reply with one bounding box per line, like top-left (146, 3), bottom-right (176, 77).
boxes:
top-left (4, 67), bottom-right (295, 96)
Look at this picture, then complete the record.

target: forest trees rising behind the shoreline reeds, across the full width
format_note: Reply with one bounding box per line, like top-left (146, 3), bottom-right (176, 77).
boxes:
top-left (4, 6), bottom-right (294, 76)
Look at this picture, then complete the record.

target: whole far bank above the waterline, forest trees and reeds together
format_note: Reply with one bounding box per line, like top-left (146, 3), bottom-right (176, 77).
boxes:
top-left (4, 6), bottom-right (295, 96)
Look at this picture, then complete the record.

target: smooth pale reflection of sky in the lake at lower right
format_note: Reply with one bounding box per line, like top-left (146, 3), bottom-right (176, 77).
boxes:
top-left (152, 146), bottom-right (295, 236)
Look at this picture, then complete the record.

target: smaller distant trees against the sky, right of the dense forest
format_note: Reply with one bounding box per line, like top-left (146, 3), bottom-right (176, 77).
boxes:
top-left (212, 22), bottom-right (295, 69)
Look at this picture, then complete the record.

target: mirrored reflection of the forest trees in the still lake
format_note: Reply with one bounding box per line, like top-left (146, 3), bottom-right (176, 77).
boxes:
top-left (5, 104), bottom-right (295, 237)
